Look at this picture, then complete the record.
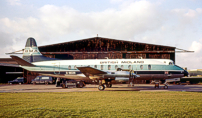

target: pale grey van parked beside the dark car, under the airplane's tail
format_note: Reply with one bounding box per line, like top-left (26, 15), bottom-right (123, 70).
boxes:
top-left (31, 76), bottom-right (55, 84)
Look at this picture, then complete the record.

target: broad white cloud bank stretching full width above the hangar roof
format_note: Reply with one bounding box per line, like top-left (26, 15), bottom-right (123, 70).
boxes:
top-left (0, 0), bottom-right (202, 67)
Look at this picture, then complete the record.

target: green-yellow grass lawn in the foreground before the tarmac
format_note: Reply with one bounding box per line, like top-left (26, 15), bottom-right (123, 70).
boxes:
top-left (0, 91), bottom-right (202, 117)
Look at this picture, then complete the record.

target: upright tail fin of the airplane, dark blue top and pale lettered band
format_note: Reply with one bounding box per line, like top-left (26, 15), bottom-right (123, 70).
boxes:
top-left (22, 37), bottom-right (55, 62)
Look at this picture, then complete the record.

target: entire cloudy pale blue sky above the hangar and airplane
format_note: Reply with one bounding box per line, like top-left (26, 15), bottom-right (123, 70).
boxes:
top-left (0, 0), bottom-right (202, 69)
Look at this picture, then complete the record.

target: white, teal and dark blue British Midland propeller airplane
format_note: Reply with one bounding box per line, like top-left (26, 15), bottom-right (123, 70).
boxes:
top-left (11, 37), bottom-right (188, 91)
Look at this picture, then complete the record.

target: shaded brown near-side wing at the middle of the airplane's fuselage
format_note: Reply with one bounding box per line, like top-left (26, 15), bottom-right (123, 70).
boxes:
top-left (77, 67), bottom-right (107, 75)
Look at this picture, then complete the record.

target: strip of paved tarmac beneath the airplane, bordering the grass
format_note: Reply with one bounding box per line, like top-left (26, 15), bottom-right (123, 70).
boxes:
top-left (0, 84), bottom-right (202, 92)
